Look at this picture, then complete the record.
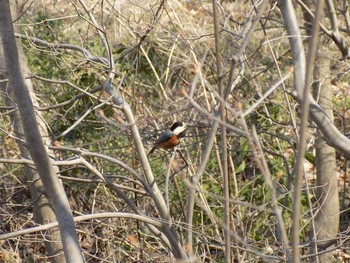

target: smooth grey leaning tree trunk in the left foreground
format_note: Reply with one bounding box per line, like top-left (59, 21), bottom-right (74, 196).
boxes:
top-left (0, 0), bottom-right (83, 262)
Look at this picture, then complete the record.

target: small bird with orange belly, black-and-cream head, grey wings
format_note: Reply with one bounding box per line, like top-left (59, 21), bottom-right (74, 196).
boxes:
top-left (148, 121), bottom-right (187, 155)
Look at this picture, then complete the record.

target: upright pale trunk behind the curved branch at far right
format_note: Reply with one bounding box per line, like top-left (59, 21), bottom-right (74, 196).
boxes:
top-left (313, 50), bottom-right (340, 262)
